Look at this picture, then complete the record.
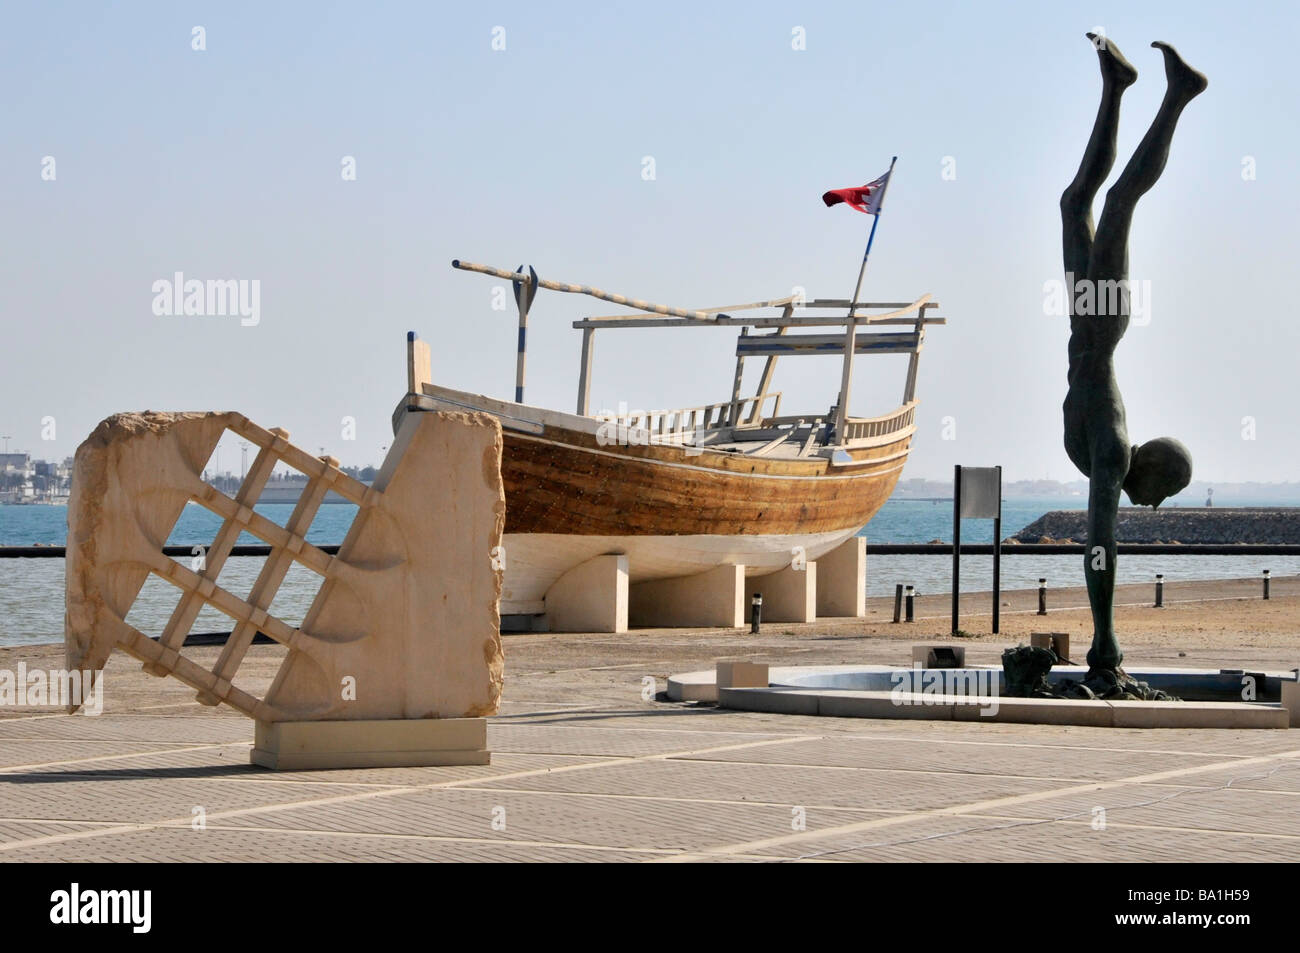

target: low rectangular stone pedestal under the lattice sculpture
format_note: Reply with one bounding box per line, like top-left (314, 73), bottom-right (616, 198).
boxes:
top-left (250, 718), bottom-right (491, 771)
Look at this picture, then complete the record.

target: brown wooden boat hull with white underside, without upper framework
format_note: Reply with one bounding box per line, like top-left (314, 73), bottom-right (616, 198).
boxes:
top-left (398, 384), bottom-right (914, 615)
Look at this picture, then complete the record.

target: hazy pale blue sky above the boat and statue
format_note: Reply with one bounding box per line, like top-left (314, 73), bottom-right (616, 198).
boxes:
top-left (0, 0), bottom-right (1300, 481)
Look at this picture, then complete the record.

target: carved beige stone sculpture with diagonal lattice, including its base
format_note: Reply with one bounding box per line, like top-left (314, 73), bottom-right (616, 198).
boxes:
top-left (65, 412), bottom-right (506, 770)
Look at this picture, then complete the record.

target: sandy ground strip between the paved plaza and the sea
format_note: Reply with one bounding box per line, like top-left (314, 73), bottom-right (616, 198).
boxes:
top-left (0, 577), bottom-right (1300, 718)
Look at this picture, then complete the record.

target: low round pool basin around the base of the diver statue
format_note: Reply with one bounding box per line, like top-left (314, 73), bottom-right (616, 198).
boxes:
top-left (667, 660), bottom-right (1300, 728)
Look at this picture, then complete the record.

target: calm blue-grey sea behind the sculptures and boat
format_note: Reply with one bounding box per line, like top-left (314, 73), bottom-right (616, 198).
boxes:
top-left (0, 497), bottom-right (1300, 645)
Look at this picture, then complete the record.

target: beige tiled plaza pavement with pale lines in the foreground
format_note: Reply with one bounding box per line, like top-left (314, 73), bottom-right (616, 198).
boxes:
top-left (0, 608), bottom-right (1300, 862)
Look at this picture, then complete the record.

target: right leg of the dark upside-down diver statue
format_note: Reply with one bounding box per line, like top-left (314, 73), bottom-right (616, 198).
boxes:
top-left (1087, 43), bottom-right (1206, 281)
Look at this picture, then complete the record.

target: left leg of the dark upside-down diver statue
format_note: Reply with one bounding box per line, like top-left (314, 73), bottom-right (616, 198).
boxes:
top-left (1061, 33), bottom-right (1138, 278)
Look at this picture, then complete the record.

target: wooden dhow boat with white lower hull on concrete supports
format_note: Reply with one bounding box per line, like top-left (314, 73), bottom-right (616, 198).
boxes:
top-left (393, 260), bottom-right (945, 631)
